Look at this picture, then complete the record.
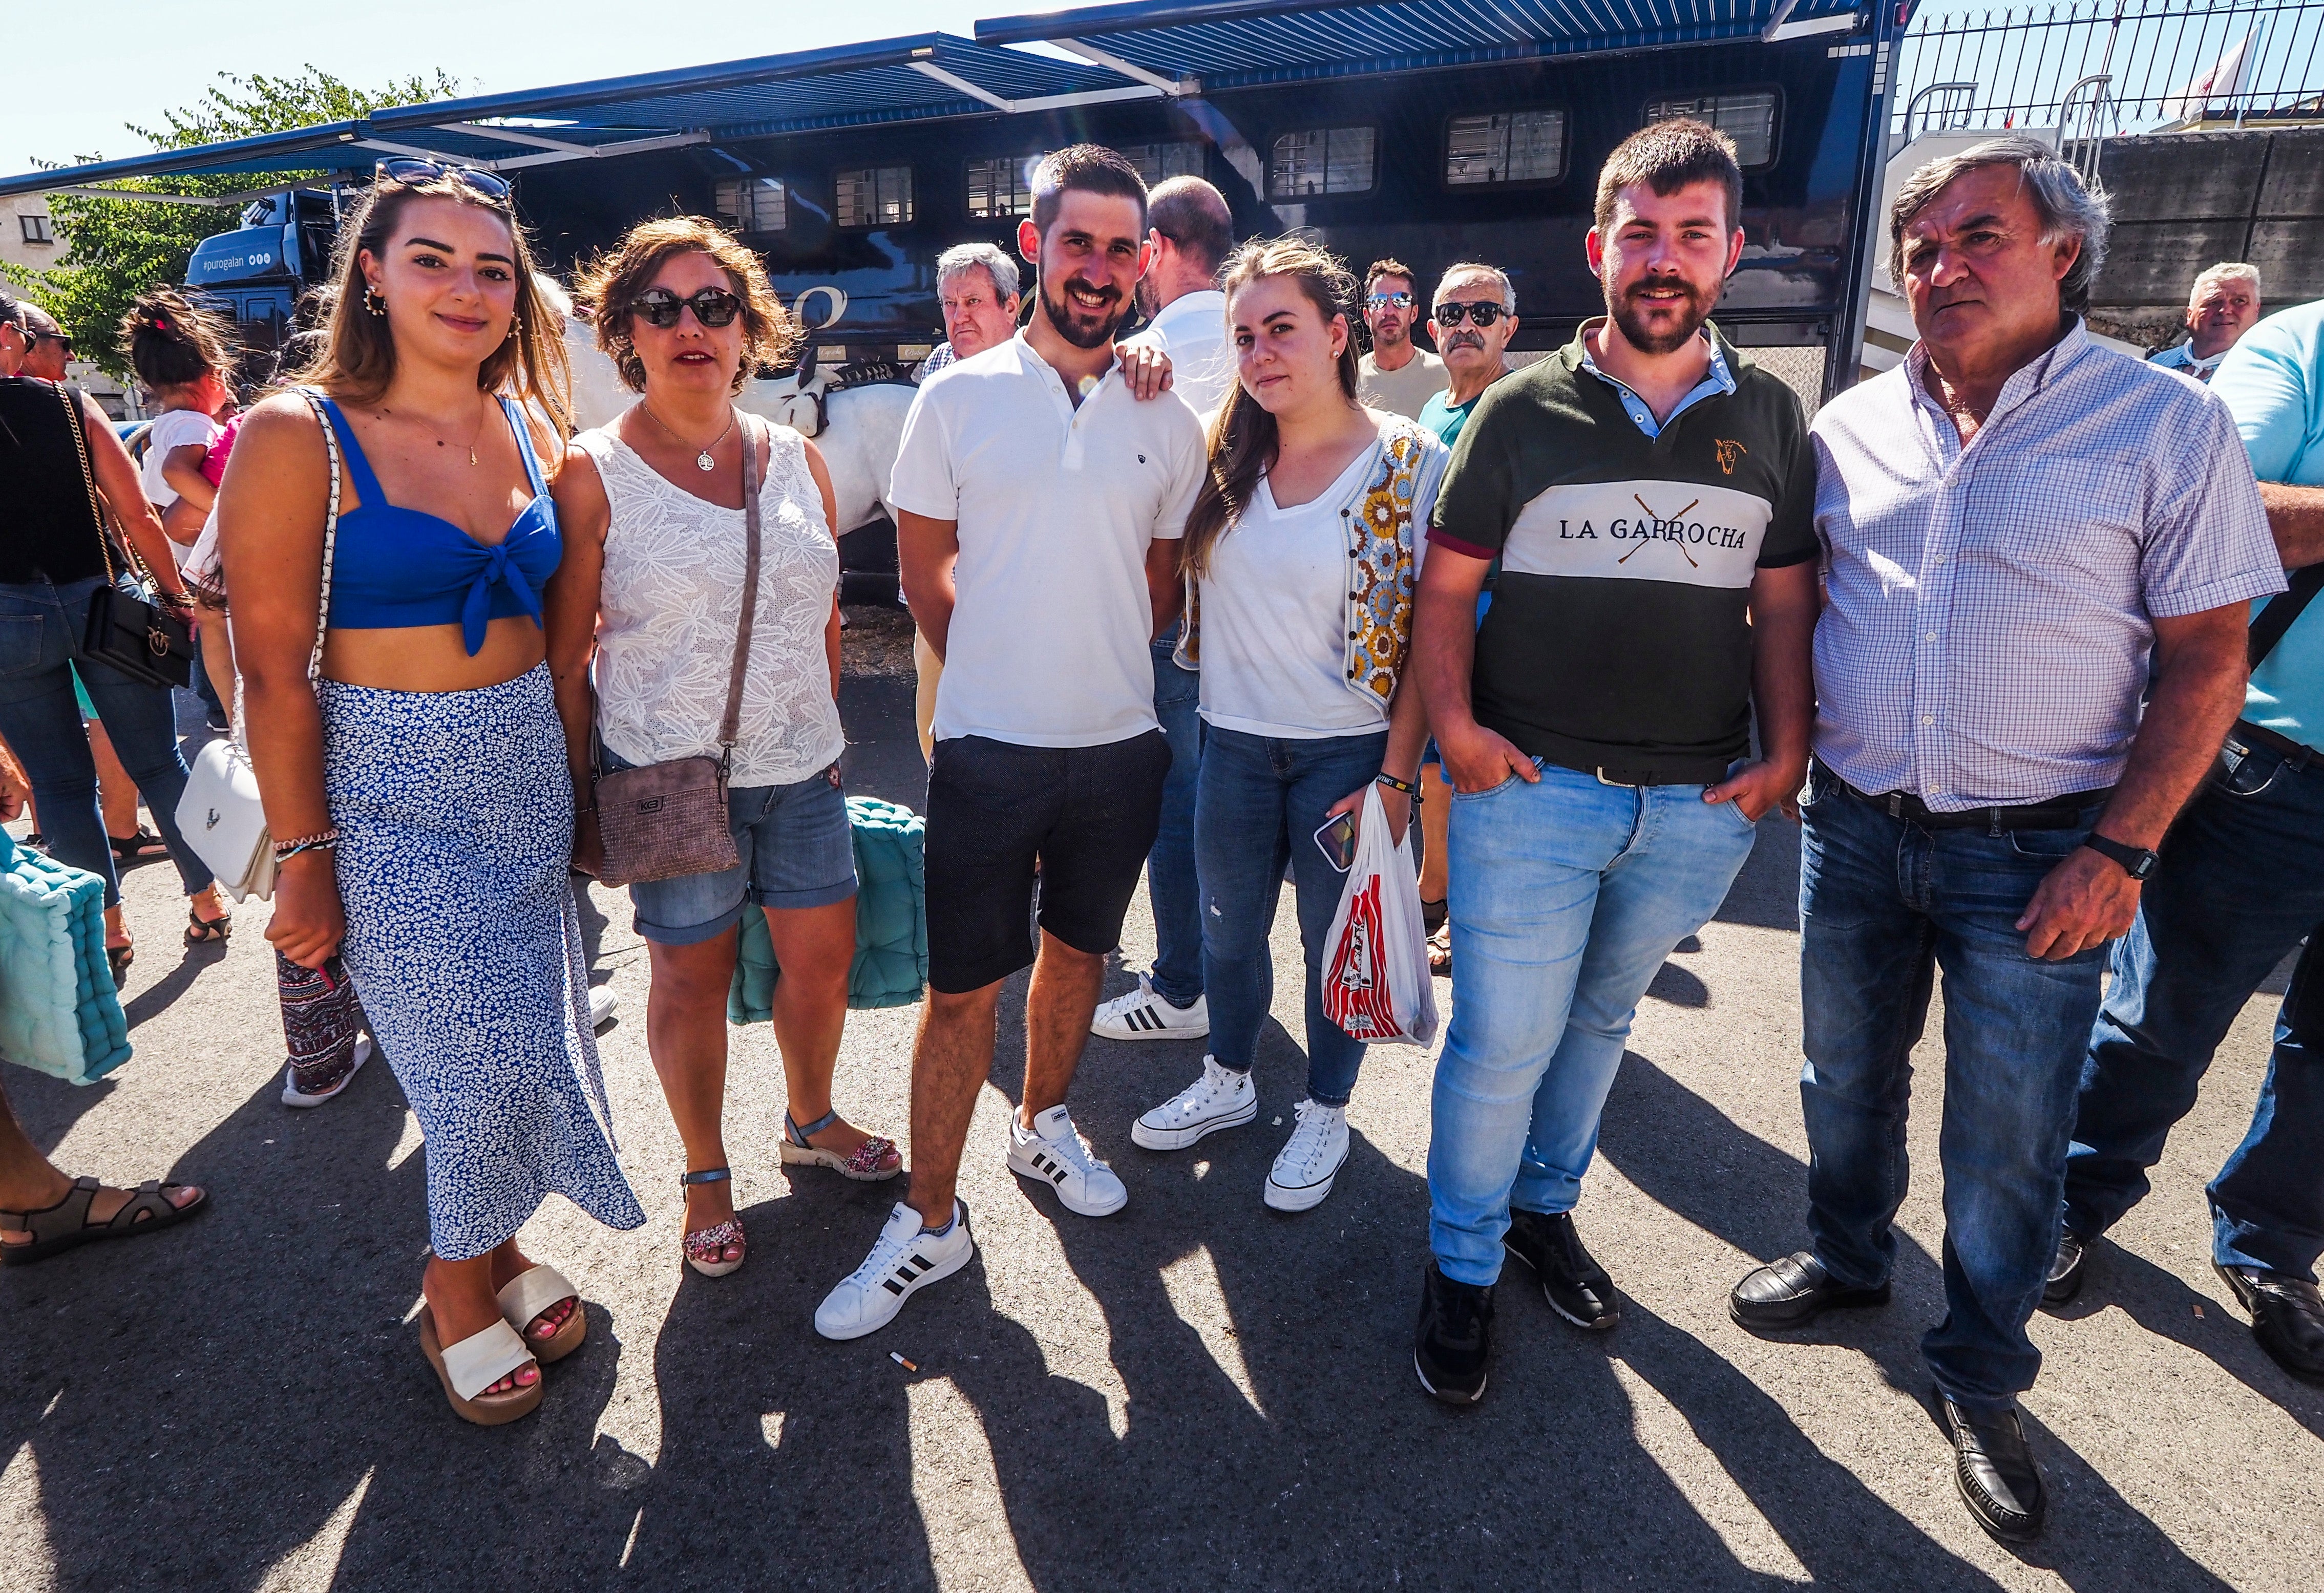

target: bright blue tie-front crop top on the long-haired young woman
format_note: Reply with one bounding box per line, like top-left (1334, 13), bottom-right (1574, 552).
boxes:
top-left (323, 399), bottom-right (565, 657)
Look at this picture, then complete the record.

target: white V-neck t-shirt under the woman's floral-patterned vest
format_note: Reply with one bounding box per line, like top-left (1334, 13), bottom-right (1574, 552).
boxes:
top-left (1201, 443), bottom-right (1394, 741)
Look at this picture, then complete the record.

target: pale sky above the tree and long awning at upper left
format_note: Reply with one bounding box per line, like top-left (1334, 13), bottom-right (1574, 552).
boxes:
top-left (0, 0), bottom-right (990, 177)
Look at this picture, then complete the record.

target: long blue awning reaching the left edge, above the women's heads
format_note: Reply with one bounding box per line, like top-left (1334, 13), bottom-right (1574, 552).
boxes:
top-left (0, 32), bottom-right (1159, 195)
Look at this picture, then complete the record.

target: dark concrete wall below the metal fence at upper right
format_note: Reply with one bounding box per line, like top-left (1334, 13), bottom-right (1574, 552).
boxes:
top-left (2066, 128), bottom-right (2324, 348)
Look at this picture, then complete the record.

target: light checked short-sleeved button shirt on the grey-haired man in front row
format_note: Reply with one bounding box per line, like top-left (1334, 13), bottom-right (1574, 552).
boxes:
top-left (1808, 323), bottom-right (2285, 813)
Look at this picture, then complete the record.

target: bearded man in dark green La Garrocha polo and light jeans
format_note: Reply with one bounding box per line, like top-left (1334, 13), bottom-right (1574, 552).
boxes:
top-left (1413, 121), bottom-right (1818, 1403)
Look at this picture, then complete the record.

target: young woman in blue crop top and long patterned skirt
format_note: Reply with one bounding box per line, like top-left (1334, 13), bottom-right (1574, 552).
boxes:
top-left (219, 160), bottom-right (644, 1424)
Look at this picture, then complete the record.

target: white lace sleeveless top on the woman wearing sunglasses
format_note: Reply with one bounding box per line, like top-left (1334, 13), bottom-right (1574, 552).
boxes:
top-left (574, 425), bottom-right (846, 785)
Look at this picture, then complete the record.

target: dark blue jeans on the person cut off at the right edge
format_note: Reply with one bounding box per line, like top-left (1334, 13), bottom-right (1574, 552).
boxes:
top-left (2066, 736), bottom-right (2324, 1282)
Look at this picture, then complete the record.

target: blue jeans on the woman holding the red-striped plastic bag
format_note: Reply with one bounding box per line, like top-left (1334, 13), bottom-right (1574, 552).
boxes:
top-left (1195, 725), bottom-right (1387, 1106)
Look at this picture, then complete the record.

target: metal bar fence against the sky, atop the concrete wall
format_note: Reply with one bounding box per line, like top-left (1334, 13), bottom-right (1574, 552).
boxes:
top-left (1894, 0), bottom-right (2324, 139)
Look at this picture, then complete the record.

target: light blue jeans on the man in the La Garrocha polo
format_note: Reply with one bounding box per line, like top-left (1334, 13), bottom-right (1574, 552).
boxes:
top-left (1429, 759), bottom-right (1755, 1284)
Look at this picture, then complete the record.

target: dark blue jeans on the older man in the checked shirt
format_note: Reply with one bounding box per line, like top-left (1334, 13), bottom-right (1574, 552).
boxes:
top-left (1799, 764), bottom-right (2105, 1407)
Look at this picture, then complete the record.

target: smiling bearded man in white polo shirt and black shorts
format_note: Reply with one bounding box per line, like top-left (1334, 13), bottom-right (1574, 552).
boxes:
top-left (816, 144), bottom-right (1204, 1337)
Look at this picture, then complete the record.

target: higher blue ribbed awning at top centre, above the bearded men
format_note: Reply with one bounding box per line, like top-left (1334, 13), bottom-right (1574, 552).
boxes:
top-left (976, 0), bottom-right (1864, 91)
